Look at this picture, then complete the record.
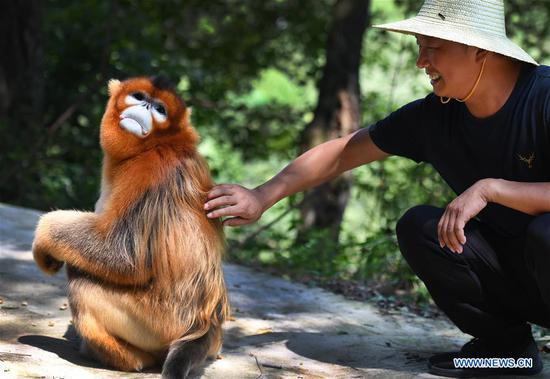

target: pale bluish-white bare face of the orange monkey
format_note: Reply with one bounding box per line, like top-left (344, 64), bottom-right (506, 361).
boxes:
top-left (119, 91), bottom-right (168, 138)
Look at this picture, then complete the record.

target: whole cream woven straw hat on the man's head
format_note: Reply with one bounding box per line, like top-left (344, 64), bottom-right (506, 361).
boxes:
top-left (373, 0), bottom-right (538, 65)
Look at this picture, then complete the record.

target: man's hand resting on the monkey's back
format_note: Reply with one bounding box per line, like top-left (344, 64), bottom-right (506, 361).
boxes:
top-left (204, 184), bottom-right (265, 226)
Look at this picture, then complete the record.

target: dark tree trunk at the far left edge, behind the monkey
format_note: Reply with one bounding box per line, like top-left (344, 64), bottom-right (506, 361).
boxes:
top-left (0, 0), bottom-right (44, 203)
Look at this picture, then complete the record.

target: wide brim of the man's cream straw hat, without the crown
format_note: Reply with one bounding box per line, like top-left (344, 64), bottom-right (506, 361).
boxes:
top-left (373, 16), bottom-right (538, 66)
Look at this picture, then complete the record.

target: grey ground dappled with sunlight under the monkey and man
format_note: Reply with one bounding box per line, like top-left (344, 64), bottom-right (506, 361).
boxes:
top-left (0, 204), bottom-right (550, 379)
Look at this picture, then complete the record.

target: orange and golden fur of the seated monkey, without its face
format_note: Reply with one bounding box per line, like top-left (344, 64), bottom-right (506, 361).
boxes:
top-left (33, 78), bottom-right (229, 376)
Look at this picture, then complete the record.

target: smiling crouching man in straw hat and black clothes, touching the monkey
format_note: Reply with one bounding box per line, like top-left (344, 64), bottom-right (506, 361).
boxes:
top-left (205, 0), bottom-right (550, 377)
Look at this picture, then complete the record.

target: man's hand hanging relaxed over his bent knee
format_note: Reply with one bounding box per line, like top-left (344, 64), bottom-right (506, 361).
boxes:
top-left (437, 179), bottom-right (496, 254)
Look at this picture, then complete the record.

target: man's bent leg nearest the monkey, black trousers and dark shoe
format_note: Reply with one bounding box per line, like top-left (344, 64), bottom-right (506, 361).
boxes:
top-left (396, 205), bottom-right (542, 377)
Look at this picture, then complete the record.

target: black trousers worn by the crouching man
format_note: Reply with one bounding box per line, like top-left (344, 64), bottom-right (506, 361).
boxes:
top-left (396, 205), bottom-right (550, 342)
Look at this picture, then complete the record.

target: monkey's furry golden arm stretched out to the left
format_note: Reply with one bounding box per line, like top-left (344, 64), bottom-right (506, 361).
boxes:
top-left (33, 211), bottom-right (151, 285)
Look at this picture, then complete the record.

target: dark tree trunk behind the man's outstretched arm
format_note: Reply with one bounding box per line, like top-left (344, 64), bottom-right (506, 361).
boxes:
top-left (297, 0), bottom-right (370, 248)
